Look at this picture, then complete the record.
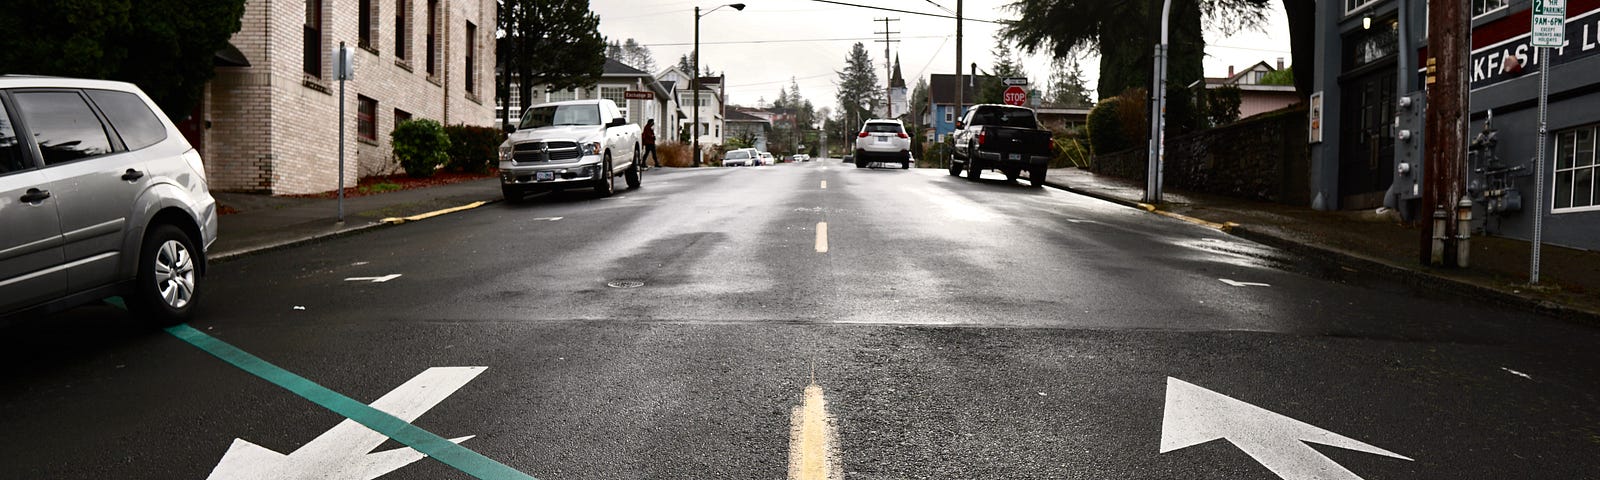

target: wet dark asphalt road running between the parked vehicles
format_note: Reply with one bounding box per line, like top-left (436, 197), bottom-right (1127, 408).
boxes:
top-left (0, 160), bottom-right (1600, 478)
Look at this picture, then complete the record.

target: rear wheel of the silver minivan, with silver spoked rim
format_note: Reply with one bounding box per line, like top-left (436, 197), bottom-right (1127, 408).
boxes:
top-left (126, 224), bottom-right (205, 326)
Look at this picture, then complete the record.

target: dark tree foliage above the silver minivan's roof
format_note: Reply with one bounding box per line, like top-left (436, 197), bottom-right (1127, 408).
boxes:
top-left (0, 0), bottom-right (246, 120)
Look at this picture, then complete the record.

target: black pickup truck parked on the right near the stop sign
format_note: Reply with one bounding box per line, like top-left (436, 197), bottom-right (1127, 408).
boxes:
top-left (950, 106), bottom-right (1056, 187)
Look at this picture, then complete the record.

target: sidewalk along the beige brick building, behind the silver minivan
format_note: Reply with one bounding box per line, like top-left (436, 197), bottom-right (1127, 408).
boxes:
top-left (208, 178), bottom-right (501, 259)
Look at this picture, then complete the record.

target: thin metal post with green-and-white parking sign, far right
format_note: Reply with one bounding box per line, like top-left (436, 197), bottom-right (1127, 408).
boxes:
top-left (1528, 0), bottom-right (1566, 285)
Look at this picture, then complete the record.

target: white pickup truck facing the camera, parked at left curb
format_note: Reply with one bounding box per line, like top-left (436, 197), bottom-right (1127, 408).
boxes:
top-left (499, 99), bottom-right (643, 202)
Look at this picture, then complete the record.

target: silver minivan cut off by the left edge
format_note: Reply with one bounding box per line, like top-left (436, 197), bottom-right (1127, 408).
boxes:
top-left (0, 75), bottom-right (218, 325)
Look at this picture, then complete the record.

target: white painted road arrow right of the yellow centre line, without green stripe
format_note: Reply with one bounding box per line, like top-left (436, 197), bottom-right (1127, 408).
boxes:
top-left (1162, 378), bottom-right (1411, 480)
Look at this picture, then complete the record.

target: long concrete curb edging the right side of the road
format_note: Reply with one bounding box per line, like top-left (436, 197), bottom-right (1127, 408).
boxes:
top-left (1045, 179), bottom-right (1600, 325)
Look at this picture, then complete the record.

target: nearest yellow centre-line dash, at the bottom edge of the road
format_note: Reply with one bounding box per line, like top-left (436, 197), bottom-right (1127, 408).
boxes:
top-left (789, 384), bottom-right (845, 480)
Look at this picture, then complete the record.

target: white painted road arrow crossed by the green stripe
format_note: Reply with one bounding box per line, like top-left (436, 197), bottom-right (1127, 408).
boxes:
top-left (206, 366), bottom-right (485, 480)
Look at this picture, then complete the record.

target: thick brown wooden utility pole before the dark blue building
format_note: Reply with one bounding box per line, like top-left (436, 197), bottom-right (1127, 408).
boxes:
top-left (1420, 2), bottom-right (1472, 267)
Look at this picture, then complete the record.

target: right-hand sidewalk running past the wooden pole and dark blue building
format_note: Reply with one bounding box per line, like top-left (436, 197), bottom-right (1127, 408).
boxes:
top-left (1046, 168), bottom-right (1600, 323)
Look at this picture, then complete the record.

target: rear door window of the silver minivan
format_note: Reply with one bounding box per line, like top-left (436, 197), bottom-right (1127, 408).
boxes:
top-left (11, 91), bottom-right (110, 165)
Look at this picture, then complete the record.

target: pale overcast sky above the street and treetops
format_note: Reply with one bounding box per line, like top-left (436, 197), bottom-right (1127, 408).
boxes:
top-left (589, 0), bottom-right (1290, 107)
